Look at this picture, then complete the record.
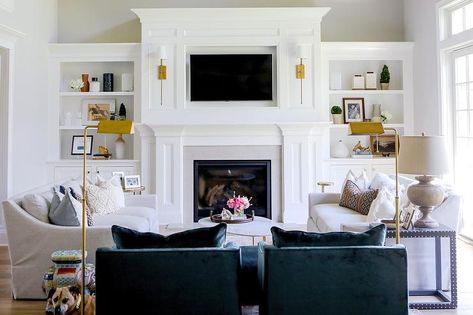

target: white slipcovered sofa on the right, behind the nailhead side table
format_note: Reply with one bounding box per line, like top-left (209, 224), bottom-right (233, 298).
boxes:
top-left (307, 177), bottom-right (461, 290)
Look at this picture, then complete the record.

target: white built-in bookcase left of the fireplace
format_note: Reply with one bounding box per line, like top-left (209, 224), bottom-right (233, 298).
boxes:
top-left (48, 44), bottom-right (141, 178)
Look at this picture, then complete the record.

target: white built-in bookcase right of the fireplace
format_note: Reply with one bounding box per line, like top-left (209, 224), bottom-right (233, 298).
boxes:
top-left (322, 42), bottom-right (413, 191)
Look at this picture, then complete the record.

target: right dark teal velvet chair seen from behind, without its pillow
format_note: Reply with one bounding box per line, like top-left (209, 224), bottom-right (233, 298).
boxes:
top-left (258, 243), bottom-right (409, 315)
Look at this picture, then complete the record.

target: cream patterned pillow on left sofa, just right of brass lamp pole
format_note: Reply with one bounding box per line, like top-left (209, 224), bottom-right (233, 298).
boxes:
top-left (87, 182), bottom-right (118, 215)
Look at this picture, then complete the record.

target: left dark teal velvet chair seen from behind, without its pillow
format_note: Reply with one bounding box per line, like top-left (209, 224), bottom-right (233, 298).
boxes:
top-left (96, 247), bottom-right (241, 315)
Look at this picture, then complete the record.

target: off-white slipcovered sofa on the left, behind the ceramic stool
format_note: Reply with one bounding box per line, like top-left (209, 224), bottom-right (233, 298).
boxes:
top-left (3, 181), bottom-right (159, 299)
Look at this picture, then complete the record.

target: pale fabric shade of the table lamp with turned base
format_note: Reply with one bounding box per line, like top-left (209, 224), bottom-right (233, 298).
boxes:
top-left (399, 136), bottom-right (449, 176)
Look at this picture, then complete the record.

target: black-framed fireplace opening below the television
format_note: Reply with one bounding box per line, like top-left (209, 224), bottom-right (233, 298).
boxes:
top-left (194, 160), bottom-right (271, 222)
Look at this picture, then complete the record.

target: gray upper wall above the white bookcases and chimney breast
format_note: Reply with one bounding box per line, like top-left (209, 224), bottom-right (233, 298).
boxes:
top-left (58, 0), bottom-right (404, 43)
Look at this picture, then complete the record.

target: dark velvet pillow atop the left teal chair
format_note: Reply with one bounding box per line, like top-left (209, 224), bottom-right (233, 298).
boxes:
top-left (112, 223), bottom-right (227, 249)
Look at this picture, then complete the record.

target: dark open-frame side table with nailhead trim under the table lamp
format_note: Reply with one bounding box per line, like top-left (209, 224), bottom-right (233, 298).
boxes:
top-left (386, 225), bottom-right (457, 310)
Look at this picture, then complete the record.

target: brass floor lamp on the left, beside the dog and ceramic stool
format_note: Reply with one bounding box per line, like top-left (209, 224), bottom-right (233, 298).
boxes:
top-left (80, 120), bottom-right (134, 315)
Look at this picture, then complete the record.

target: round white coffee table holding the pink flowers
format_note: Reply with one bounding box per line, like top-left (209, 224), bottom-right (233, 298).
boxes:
top-left (198, 216), bottom-right (277, 245)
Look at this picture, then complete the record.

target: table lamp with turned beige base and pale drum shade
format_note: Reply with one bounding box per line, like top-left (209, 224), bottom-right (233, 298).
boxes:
top-left (399, 135), bottom-right (449, 228)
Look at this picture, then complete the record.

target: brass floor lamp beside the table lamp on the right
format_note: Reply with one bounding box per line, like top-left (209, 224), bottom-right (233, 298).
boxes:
top-left (350, 122), bottom-right (401, 244)
